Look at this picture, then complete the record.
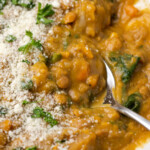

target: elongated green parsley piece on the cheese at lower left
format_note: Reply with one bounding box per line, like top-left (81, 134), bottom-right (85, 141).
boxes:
top-left (31, 107), bottom-right (58, 127)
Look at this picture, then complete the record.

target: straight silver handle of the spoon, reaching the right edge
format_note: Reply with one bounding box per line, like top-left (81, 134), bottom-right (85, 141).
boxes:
top-left (112, 103), bottom-right (150, 130)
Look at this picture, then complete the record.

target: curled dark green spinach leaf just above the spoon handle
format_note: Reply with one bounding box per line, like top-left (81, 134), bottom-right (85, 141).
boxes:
top-left (123, 93), bottom-right (142, 112)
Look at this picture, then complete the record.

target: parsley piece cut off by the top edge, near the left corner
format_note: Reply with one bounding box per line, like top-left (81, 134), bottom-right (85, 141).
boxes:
top-left (11, 0), bottom-right (35, 9)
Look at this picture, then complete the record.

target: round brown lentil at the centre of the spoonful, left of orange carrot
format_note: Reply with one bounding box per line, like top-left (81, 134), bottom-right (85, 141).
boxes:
top-left (56, 76), bottom-right (69, 89)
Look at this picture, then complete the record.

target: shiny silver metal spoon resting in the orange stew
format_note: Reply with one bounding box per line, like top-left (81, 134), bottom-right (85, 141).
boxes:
top-left (104, 61), bottom-right (150, 130)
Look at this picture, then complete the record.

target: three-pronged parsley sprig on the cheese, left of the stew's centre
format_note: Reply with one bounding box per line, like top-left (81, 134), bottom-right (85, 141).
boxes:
top-left (18, 31), bottom-right (43, 54)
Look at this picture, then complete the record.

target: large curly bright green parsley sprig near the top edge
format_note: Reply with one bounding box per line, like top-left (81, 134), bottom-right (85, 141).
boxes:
top-left (36, 3), bottom-right (55, 25)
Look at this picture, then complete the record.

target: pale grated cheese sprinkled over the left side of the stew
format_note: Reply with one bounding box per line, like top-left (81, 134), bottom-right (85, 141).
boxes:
top-left (0, 0), bottom-right (75, 150)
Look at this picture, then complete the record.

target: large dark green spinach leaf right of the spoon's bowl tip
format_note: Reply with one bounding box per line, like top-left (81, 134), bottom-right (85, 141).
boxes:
top-left (109, 53), bottom-right (140, 83)
